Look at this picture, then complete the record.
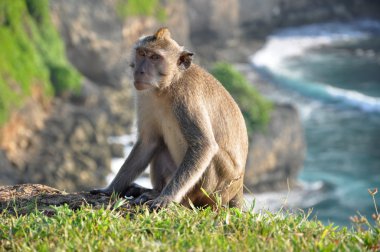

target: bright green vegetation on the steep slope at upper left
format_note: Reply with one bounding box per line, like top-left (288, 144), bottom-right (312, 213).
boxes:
top-left (0, 0), bottom-right (80, 125)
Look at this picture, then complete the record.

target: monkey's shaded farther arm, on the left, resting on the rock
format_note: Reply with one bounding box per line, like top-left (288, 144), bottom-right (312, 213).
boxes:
top-left (90, 139), bottom-right (158, 195)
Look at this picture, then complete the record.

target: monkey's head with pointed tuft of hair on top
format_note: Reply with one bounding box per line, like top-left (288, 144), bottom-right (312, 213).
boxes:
top-left (131, 28), bottom-right (193, 90)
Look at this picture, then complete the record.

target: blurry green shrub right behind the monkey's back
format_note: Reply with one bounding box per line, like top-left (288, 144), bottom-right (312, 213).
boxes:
top-left (211, 63), bottom-right (272, 135)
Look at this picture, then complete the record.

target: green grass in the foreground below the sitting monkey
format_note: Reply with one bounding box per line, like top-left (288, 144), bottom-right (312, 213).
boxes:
top-left (0, 202), bottom-right (380, 251)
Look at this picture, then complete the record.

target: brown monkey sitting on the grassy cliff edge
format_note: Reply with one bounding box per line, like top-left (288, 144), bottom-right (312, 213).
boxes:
top-left (91, 28), bottom-right (248, 209)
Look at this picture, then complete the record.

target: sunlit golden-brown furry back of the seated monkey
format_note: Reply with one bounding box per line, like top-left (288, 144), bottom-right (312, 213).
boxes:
top-left (177, 64), bottom-right (248, 172)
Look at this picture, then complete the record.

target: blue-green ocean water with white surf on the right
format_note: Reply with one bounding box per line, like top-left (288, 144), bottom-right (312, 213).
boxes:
top-left (251, 20), bottom-right (380, 225)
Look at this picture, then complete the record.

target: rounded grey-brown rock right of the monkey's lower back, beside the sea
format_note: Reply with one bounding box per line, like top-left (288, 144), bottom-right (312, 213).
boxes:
top-left (244, 104), bottom-right (305, 193)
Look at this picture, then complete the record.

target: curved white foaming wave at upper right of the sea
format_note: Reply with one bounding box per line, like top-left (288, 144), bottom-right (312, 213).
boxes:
top-left (250, 20), bottom-right (380, 112)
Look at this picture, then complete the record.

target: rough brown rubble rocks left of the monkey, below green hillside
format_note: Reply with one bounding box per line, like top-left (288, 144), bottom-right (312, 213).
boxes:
top-left (0, 80), bottom-right (133, 191)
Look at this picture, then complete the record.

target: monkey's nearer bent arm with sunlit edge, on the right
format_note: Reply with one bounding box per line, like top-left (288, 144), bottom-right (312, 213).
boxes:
top-left (150, 104), bottom-right (219, 208)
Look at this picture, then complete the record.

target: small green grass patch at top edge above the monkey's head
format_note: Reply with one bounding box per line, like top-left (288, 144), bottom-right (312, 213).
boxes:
top-left (116, 0), bottom-right (167, 22)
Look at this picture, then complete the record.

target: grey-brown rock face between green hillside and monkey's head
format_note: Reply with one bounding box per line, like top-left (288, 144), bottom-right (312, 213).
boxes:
top-left (51, 0), bottom-right (128, 87)
